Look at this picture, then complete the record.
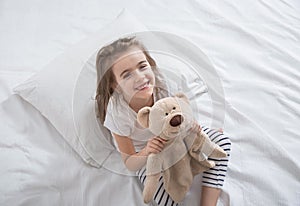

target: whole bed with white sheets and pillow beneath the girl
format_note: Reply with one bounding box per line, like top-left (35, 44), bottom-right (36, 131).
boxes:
top-left (0, 0), bottom-right (300, 206)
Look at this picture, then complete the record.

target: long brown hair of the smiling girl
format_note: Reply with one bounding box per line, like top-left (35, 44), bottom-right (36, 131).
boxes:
top-left (96, 37), bottom-right (168, 124)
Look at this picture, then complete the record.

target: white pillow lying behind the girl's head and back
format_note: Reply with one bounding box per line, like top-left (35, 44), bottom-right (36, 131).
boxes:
top-left (14, 10), bottom-right (214, 174)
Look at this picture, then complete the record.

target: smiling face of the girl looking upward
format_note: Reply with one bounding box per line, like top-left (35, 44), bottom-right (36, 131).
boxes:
top-left (112, 47), bottom-right (155, 103)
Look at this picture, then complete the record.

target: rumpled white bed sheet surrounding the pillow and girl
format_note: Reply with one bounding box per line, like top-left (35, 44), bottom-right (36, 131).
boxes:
top-left (0, 0), bottom-right (300, 206)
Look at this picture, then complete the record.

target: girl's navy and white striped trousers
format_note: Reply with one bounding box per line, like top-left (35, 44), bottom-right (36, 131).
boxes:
top-left (137, 127), bottom-right (231, 206)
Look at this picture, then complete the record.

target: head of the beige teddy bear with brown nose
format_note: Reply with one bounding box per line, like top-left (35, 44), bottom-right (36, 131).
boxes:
top-left (137, 93), bottom-right (193, 139)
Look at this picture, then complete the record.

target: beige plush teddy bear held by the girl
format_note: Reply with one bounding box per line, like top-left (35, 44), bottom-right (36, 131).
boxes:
top-left (137, 93), bottom-right (227, 203)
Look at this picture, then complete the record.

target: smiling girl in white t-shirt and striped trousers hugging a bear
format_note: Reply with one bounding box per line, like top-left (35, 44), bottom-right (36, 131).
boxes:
top-left (96, 37), bottom-right (231, 206)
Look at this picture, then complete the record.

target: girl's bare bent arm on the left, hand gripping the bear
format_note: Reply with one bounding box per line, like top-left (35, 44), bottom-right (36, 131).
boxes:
top-left (113, 134), bottom-right (164, 171)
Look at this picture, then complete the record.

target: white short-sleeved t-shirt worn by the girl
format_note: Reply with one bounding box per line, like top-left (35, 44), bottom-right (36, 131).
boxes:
top-left (104, 92), bottom-right (155, 151)
